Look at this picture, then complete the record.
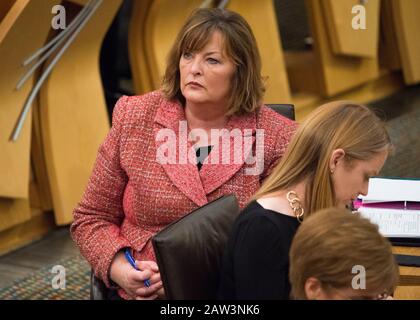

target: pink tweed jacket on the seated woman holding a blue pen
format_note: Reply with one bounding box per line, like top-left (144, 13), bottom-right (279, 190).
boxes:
top-left (70, 91), bottom-right (296, 286)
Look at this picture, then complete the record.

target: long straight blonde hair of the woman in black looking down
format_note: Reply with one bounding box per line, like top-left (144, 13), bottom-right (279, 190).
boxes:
top-left (251, 101), bottom-right (392, 217)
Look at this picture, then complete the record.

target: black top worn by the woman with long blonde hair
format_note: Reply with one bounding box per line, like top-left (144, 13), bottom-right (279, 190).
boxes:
top-left (219, 201), bottom-right (300, 300)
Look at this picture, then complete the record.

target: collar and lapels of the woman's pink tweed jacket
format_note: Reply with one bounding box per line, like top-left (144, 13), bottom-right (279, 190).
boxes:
top-left (154, 100), bottom-right (257, 202)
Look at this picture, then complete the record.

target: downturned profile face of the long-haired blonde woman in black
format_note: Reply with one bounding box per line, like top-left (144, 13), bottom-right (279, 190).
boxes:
top-left (330, 149), bottom-right (388, 207)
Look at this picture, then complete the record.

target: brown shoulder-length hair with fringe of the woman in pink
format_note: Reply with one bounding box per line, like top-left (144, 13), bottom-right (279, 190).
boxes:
top-left (162, 8), bottom-right (265, 116)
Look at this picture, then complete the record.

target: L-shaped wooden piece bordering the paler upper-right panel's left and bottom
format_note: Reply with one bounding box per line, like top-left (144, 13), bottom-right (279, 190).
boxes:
top-left (305, 0), bottom-right (379, 96)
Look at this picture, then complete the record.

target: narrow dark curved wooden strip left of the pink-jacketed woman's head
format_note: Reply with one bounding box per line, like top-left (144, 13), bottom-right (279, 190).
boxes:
top-left (128, 0), bottom-right (154, 94)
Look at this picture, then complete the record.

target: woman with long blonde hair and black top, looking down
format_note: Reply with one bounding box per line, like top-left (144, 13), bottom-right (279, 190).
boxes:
top-left (220, 101), bottom-right (392, 299)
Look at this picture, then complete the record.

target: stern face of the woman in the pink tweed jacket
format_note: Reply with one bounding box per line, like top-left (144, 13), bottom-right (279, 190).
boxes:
top-left (179, 31), bottom-right (235, 107)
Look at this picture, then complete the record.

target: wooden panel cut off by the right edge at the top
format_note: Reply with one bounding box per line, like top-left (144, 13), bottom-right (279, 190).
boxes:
top-left (392, 0), bottom-right (420, 84)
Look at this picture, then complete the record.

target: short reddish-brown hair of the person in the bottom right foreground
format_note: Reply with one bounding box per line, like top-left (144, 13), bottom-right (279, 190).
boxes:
top-left (289, 208), bottom-right (399, 299)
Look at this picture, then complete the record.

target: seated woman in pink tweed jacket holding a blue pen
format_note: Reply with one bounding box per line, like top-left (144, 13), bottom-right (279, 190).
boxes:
top-left (71, 9), bottom-right (296, 299)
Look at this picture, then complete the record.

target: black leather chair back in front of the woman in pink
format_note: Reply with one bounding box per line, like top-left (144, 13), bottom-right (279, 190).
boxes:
top-left (152, 195), bottom-right (240, 300)
